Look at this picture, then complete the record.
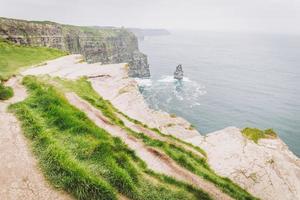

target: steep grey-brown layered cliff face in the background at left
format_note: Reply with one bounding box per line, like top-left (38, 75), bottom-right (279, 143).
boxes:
top-left (0, 18), bottom-right (150, 77)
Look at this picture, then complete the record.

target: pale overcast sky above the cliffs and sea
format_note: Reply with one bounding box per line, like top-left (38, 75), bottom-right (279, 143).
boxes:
top-left (0, 0), bottom-right (300, 33)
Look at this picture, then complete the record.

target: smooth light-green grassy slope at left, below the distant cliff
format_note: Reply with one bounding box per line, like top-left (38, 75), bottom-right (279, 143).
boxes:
top-left (0, 39), bottom-right (66, 80)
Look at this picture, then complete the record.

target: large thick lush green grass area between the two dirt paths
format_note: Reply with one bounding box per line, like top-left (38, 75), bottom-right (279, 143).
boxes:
top-left (10, 76), bottom-right (211, 200)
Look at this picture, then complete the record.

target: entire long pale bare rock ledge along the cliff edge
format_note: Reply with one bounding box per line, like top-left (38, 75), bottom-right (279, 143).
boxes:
top-left (22, 55), bottom-right (300, 199)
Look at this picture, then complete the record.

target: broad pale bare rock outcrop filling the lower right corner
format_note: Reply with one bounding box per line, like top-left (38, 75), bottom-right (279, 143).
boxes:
top-left (186, 127), bottom-right (300, 200)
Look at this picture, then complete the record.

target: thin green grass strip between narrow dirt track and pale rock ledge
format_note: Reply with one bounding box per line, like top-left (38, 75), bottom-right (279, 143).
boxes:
top-left (52, 78), bottom-right (256, 199)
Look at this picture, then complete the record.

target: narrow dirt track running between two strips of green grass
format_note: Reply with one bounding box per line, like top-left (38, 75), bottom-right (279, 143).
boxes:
top-left (66, 93), bottom-right (231, 200)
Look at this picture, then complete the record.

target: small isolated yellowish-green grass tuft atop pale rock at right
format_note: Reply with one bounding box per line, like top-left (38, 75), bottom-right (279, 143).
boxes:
top-left (242, 127), bottom-right (277, 143)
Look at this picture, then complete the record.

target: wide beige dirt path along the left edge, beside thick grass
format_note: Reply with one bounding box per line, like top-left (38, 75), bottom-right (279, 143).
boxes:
top-left (0, 78), bottom-right (71, 200)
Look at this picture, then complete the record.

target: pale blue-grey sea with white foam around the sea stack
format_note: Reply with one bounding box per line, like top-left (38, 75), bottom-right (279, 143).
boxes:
top-left (138, 31), bottom-right (300, 155)
